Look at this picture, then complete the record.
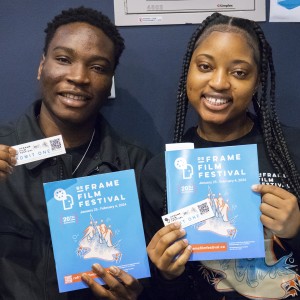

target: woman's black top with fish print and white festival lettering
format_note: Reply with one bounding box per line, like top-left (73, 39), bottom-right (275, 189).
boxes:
top-left (141, 119), bottom-right (300, 300)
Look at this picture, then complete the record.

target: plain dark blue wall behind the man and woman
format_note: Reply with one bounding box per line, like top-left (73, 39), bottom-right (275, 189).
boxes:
top-left (0, 0), bottom-right (300, 153)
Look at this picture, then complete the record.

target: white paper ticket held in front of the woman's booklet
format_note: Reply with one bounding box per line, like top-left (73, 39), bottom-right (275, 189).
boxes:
top-left (162, 199), bottom-right (214, 228)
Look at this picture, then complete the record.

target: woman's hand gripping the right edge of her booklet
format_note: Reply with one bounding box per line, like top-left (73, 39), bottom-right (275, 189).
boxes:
top-left (252, 184), bottom-right (300, 238)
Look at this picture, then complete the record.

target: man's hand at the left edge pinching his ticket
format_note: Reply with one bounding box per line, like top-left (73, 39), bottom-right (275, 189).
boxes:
top-left (0, 145), bottom-right (16, 180)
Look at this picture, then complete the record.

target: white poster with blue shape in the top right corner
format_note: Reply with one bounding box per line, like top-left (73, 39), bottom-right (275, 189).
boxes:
top-left (270, 0), bottom-right (300, 22)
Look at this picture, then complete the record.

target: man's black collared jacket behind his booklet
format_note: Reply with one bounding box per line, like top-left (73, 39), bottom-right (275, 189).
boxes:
top-left (0, 101), bottom-right (149, 300)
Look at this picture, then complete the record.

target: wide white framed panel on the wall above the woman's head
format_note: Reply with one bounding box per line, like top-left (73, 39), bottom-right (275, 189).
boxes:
top-left (114, 0), bottom-right (266, 26)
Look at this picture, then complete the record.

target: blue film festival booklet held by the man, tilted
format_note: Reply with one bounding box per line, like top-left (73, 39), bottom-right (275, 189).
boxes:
top-left (44, 170), bottom-right (150, 292)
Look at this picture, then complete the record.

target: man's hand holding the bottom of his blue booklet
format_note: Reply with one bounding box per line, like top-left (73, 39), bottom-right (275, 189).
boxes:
top-left (81, 264), bottom-right (143, 300)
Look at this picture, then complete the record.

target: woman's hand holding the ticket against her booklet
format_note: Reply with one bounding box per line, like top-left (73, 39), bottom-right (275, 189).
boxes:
top-left (147, 223), bottom-right (192, 279)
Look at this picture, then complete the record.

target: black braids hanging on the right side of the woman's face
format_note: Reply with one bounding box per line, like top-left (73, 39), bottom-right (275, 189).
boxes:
top-left (253, 22), bottom-right (300, 201)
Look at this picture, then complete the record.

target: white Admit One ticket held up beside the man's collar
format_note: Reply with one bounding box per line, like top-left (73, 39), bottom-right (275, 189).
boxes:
top-left (12, 135), bottom-right (66, 166)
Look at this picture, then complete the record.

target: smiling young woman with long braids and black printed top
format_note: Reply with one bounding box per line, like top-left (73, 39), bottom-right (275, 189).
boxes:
top-left (142, 13), bottom-right (300, 300)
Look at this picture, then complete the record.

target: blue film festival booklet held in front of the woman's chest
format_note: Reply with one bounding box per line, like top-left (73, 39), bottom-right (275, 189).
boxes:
top-left (165, 144), bottom-right (265, 260)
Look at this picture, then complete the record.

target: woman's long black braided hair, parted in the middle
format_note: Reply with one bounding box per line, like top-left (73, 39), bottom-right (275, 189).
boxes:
top-left (169, 13), bottom-right (300, 213)
